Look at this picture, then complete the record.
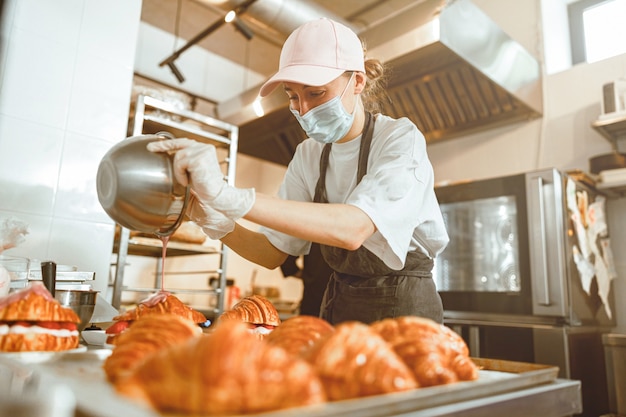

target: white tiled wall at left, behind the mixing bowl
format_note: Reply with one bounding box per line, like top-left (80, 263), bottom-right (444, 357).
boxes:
top-left (0, 0), bottom-right (141, 292)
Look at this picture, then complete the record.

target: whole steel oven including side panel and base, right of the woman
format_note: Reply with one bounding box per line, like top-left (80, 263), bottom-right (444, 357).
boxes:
top-left (434, 169), bottom-right (615, 416)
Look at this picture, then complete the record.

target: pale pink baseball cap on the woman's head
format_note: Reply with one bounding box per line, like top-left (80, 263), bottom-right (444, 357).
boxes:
top-left (259, 18), bottom-right (365, 97)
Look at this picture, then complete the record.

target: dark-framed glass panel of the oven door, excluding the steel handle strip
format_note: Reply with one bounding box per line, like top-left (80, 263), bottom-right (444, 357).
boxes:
top-left (433, 174), bottom-right (533, 316)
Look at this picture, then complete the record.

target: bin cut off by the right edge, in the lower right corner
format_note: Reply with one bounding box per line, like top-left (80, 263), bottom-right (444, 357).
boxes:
top-left (602, 333), bottom-right (626, 416)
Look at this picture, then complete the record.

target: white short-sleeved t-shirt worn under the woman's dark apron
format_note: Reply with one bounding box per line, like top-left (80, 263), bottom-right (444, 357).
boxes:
top-left (261, 114), bottom-right (449, 270)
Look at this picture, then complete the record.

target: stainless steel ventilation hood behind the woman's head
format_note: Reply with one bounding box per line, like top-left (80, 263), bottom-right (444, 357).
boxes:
top-left (217, 0), bottom-right (542, 165)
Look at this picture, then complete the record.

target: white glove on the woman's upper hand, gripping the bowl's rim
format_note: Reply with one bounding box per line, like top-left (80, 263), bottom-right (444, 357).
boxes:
top-left (147, 138), bottom-right (255, 219)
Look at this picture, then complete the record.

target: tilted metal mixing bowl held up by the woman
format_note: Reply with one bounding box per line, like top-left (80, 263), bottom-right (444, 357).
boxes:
top-left (96, 133), bottom-right (190, 236)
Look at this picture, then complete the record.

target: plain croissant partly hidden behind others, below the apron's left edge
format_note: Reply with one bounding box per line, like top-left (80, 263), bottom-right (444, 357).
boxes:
top-left (265, 316), bottom-right (335, 356)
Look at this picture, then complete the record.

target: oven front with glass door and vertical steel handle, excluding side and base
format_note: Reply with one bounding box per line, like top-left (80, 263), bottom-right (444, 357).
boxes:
top-left (433, 169), bottom-right (570, 319)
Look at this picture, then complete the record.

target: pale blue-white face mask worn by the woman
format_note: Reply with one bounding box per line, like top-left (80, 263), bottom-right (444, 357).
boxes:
top-left (290, 72), bottom-right (356, 143)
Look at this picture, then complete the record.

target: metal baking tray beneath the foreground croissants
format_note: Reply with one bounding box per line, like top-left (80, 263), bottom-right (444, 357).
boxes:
top-left (0, 349), bottom-right (559, 417)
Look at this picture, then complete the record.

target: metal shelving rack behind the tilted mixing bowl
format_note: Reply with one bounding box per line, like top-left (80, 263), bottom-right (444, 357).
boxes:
top-left (112, 94), bottom-right (239, 316)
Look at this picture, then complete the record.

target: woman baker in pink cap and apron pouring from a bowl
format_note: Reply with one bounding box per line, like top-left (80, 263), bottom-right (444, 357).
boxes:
top-left (149, 18), bottom-right (448, 324)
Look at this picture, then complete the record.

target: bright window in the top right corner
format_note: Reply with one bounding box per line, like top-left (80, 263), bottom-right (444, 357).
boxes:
top-left (568, 0), bottom-right (626, 64)
